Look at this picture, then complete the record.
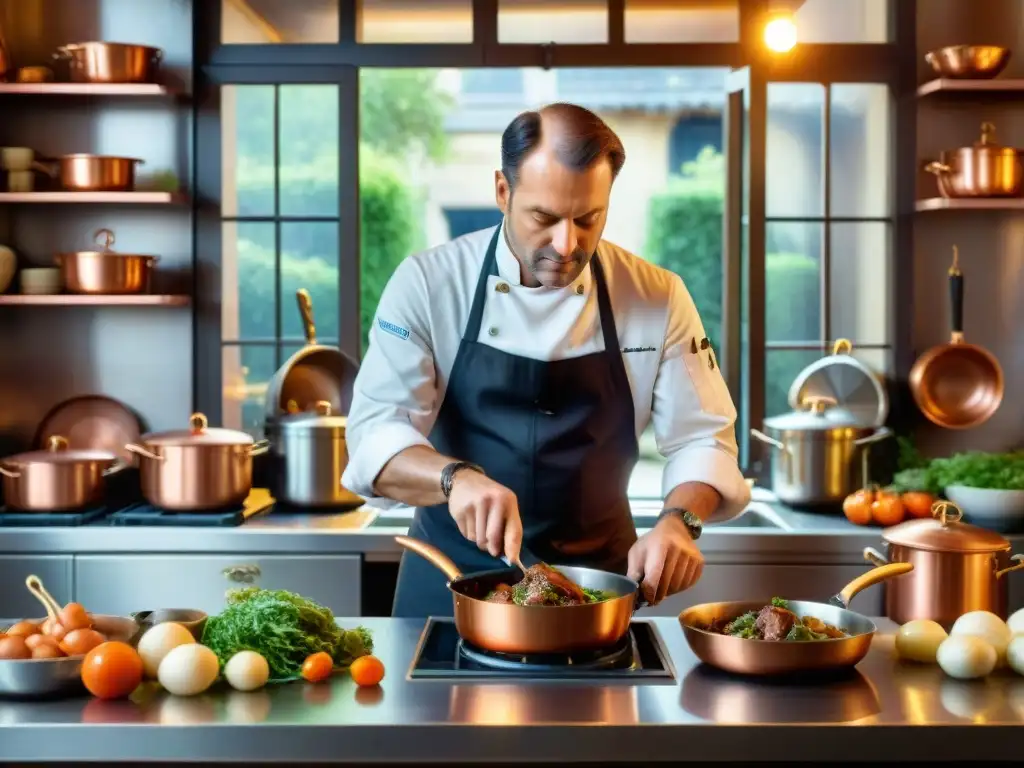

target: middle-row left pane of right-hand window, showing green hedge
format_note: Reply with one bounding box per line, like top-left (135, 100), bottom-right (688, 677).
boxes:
top-left (765, 221), bottom-right (821, 341)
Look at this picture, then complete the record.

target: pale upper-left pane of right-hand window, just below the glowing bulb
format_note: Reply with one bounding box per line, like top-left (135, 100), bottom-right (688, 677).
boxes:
top-left (765, 83), bottom-right (825, 217)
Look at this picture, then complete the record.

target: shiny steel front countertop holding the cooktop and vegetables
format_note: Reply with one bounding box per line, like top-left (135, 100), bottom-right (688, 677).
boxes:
top-left (0, 618), bottom-right (1024, 763)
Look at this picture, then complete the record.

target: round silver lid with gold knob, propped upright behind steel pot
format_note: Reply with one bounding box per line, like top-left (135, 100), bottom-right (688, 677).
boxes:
top-left (788, 339), bottom-right (889, 427)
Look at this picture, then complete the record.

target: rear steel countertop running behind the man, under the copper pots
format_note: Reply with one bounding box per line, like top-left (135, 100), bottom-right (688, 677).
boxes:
top-left (0, 488), bottom-right (1024, 563)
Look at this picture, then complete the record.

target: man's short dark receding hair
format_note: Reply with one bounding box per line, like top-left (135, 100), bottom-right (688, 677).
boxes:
top-left (502, 102), bottom-right (626, 188)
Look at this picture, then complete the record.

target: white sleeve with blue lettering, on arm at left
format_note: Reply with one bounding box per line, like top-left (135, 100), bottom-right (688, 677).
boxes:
top-left (342, 258), bottom-right (437, 507)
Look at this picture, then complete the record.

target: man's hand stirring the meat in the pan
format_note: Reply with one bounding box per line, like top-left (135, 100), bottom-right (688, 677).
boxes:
top-left (449, 470), bottom-right (522, 563)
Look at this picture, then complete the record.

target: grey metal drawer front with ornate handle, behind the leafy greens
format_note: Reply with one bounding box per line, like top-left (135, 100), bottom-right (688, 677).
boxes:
top-left (75, 554), bottom-right (360, 616)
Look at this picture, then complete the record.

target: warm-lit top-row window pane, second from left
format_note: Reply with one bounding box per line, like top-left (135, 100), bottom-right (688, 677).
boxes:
top-left (355, 0), bottom-right (473, 43)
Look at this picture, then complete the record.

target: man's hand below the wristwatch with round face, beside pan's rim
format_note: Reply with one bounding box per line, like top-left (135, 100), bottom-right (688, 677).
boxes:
top-left (628, 515), bottom-right (703, 605)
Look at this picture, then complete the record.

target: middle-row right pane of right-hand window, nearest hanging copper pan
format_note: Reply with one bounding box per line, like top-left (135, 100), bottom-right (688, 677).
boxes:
top-left (828, 222), bottom-right (893, 344)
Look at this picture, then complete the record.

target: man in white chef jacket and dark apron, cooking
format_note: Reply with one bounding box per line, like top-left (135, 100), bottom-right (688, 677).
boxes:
top-left (342, 103), bottom-right (750, 616)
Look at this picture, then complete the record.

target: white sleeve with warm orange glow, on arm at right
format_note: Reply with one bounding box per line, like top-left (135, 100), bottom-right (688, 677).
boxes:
top-left (651, 275), bottom-right (751, 522)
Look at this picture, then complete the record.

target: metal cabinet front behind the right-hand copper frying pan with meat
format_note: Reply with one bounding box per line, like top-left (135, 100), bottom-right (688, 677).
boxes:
top-left (638, 563), bottom-right (883, 616)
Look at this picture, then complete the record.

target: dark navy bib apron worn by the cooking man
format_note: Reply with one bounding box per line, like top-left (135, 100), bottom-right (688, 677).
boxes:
top-left (392, 226), bottom-right (639, 617)
